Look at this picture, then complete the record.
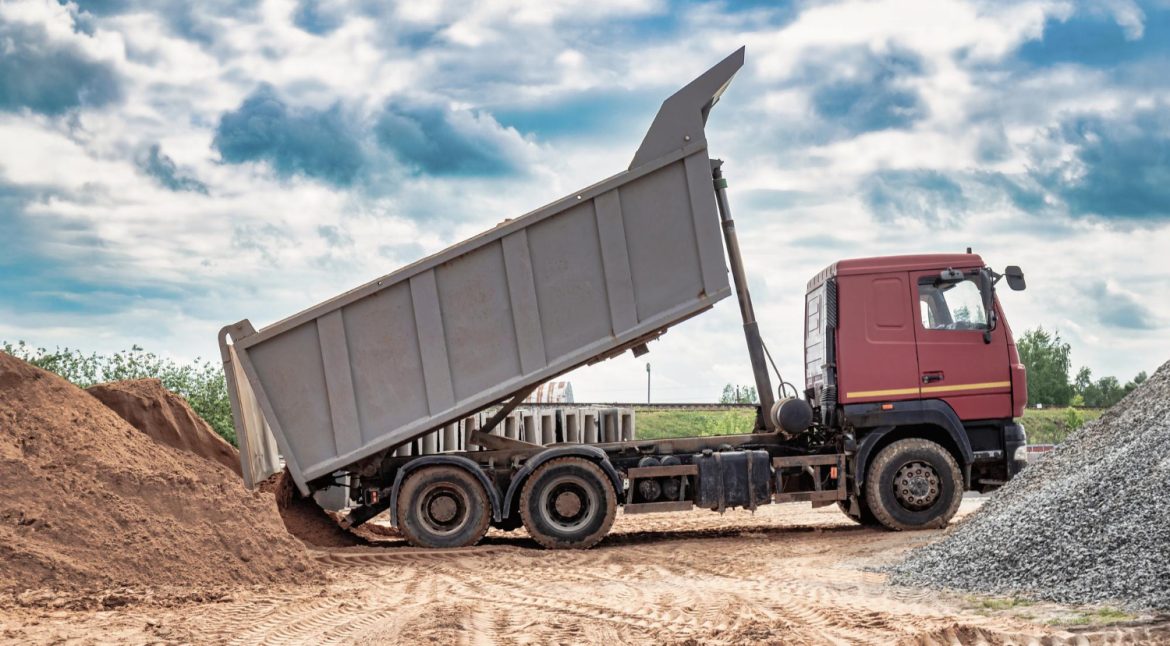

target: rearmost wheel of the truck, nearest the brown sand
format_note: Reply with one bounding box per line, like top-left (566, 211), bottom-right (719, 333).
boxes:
top-left (398, 465), bottom-right (491, 548)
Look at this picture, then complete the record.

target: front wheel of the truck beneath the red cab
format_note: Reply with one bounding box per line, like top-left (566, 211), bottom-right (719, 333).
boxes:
top-left (865, 438), bottom-right (963, 531)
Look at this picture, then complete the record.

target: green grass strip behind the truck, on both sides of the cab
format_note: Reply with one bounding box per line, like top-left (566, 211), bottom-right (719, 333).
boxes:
top-left (636, 408), bottom-right (1103, 444)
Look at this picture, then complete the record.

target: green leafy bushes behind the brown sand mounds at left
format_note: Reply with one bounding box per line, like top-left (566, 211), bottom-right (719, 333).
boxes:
top-left (2, 341), bottom-right (236, 446)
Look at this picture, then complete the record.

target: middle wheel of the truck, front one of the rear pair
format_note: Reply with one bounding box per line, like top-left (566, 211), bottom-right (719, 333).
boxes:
top-left (519, 458), bottom-right (618, 549)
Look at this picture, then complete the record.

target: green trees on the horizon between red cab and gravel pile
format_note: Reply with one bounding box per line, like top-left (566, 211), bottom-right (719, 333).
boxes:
top-left (1016, 327), bottom-right (1148, 408)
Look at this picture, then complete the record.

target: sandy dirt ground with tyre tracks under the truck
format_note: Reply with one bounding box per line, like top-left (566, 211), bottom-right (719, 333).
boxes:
top-left (0, 500), bottom-right (1170, 645)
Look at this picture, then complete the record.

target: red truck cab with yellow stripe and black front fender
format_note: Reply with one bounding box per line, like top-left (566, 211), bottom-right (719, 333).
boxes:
top-left (805, 253), bottom-right (1027, 524)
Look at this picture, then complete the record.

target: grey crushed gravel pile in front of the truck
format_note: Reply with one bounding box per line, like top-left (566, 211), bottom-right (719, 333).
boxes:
top-left (889, 363), bottom-right (1170, 610)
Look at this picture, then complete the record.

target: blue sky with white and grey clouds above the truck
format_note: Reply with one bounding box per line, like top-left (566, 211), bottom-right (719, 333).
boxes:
top-left (0, 0), bottom-right (1170, 401)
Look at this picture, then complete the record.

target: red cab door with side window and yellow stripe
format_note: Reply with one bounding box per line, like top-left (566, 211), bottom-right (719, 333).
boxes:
top-left (910, 269), bottom-right (1012, 420)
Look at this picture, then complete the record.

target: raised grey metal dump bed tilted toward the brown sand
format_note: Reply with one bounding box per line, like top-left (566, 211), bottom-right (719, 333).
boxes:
top-left (220, 49), bottom-right (743, 493)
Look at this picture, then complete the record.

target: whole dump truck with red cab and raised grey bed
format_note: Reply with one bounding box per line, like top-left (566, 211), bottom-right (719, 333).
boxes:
top-left (219, 48), bottom-right (1027, 548)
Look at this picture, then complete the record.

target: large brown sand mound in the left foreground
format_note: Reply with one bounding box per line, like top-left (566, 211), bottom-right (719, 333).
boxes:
top-left (0, 352), bottom-right (316, 595)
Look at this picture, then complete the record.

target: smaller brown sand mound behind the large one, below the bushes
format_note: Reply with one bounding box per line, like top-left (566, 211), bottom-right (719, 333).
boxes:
top-left (85, 379), bottom-right (240, 475)
